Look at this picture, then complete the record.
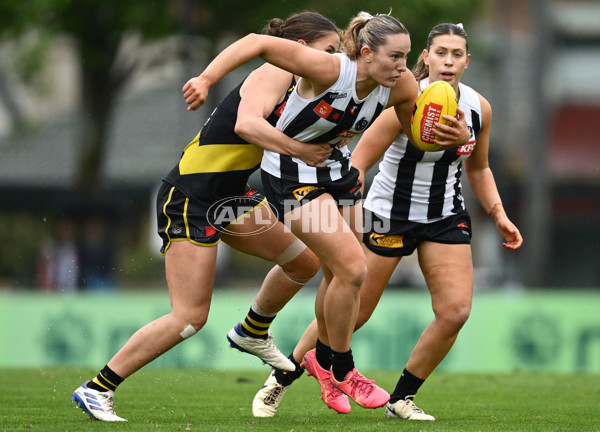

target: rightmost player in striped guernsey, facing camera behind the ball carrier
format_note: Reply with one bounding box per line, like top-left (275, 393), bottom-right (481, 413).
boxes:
top-left (246, 24), bottom-right (523, 420)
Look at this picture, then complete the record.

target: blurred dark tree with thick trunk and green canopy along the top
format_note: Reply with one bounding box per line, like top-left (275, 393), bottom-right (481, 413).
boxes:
top-left (0, 0), bottom-right (480, 199)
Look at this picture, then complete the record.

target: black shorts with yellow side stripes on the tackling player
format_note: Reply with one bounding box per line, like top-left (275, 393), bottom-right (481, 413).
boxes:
top-left (156, 181), bottom-right (266, 255)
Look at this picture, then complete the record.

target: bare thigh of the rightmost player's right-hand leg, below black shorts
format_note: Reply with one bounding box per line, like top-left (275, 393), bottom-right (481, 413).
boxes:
top-left (417, 241), bottom-right (473, 310)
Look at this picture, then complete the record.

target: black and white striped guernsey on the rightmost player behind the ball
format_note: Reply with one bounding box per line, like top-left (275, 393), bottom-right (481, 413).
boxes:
top-left (364, 78), bottom-right (481, 223)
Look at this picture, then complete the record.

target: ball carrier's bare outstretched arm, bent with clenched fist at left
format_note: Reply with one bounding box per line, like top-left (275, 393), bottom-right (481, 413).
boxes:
top-left (182, 33), bottom-right (339, 110)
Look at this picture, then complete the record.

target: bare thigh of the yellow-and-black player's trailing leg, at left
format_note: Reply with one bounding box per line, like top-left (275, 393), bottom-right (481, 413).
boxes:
top-left (165, 240), bottom-right (217, 321)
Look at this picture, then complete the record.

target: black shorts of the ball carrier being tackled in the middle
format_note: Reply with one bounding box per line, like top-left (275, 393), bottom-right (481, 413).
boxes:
top-left (261, 167), bottom-right (362, 221)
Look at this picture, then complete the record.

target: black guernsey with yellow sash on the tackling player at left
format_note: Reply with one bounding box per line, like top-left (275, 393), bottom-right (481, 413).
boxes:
top-left (165, 79), bottom-right (296, 205)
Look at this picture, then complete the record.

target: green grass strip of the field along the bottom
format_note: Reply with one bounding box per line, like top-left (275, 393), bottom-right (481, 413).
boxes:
top-left (0, 367), bottom-right (600, 432)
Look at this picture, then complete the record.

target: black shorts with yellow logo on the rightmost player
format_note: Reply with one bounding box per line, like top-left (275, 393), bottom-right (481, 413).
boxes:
top-left (363, 209), bottom-right (472, 257)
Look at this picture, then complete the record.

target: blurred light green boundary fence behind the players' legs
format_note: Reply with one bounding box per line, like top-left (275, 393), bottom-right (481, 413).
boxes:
top-left (0, 290), bottom-right (600, 373)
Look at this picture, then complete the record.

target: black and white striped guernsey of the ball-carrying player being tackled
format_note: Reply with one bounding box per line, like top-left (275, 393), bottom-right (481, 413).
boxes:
top-left (261, 53), bottom-right (390, 184)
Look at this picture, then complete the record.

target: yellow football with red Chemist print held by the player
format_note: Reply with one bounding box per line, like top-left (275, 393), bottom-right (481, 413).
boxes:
top-left (410, 81), bottom-right (458, 152)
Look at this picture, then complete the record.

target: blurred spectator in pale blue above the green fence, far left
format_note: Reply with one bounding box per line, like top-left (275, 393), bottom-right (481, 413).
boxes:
top-left (36, 218), bottom-right (80, 292)
